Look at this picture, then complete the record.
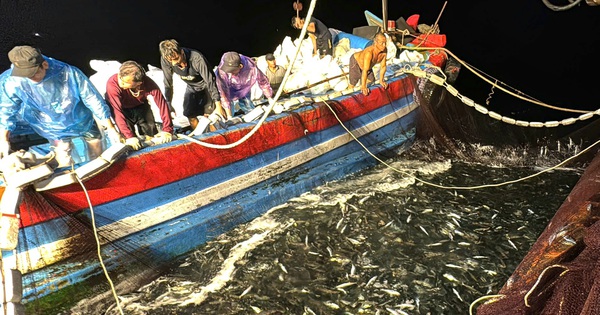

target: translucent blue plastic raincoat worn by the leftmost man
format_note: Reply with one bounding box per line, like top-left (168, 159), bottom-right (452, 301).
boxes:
top-left (0, 56), bottom-right (110, 141)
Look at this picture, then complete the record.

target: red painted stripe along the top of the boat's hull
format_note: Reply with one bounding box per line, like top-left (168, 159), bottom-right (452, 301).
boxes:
top-left (20, 77), bottom-right (414, 226)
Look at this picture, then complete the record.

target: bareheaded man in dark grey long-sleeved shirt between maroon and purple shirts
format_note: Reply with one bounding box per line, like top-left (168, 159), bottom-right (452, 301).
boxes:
top-left (159, 39), bottom-right (225, 130)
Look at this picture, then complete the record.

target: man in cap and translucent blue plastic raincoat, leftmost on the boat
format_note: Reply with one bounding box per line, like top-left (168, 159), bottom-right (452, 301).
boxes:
top-left (0, 46), bottom-right (121, 166)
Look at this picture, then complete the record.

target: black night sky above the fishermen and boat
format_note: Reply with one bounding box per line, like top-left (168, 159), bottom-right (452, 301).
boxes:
top-left (0, 0), bottom-right (600, 116)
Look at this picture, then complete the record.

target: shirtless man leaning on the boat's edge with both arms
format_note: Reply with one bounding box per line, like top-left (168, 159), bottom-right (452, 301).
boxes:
top-left (348, 33), bottom-right (388, 95)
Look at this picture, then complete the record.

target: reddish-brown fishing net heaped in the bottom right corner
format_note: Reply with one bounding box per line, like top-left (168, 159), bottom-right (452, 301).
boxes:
top-left (477, 152), bottom-right (600, 315)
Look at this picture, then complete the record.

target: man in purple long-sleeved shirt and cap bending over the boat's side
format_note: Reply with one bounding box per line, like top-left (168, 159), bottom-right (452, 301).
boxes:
top-left (217, 51), bottom-right (273, 119)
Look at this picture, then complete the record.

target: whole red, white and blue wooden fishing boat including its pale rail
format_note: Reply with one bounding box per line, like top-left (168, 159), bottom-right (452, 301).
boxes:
top-left (0, 4), bottom-right (460, 314)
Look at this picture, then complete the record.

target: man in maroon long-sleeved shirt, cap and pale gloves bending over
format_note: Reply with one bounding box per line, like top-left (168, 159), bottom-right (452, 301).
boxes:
top-left (106, 60), bottom-right (173, 150)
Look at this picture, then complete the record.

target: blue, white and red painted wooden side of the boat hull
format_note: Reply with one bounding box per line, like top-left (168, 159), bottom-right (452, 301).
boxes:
top-left (4, 75), bottom-right (418, 301)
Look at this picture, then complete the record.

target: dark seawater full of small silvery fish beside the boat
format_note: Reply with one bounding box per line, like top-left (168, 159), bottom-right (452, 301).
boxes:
top-left (63, 145), bottom-right (582, 315)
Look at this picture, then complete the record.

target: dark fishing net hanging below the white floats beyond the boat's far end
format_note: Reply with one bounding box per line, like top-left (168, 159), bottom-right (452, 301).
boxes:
top-left (417, 58), bottom-right (600, 165)
